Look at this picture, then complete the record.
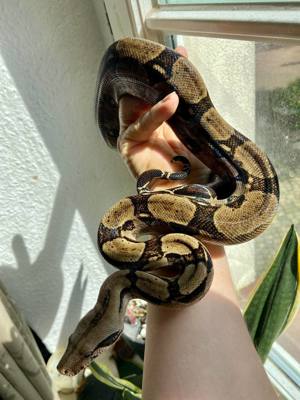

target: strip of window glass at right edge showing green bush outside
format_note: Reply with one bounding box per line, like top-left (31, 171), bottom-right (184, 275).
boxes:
top-left (255, 43), bottom-right (300, 362)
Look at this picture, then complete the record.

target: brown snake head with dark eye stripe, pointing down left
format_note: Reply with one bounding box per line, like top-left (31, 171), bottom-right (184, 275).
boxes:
top-left (57, 309), bottom-right (122, 376)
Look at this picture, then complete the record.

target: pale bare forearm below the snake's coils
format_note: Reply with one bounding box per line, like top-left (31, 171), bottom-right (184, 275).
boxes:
top-left (143, 248), bottom-right (276, 400)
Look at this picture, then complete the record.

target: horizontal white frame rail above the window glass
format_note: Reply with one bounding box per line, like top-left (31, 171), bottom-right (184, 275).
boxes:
top-left (145, 6), bottom-right (300, 43)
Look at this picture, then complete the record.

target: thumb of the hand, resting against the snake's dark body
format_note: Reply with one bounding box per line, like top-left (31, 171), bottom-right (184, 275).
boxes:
top-left (119, 92), bottom-right (179, 146)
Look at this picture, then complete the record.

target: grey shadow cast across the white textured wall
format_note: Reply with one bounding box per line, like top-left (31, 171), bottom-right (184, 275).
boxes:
top-left (0, 0), bottom-right (129, 337)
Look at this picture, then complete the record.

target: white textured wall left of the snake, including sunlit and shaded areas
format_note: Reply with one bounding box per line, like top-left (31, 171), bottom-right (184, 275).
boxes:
top-left (0, 0), bottom-right (134, 350)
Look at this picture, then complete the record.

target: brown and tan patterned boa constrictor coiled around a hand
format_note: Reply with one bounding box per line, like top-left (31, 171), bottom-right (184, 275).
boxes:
top-left (58, 38), bottom-right (279, 375)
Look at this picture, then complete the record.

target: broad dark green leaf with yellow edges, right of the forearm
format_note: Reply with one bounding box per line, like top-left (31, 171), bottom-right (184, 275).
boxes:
top-left (244, 225), bottom-right (300, 361)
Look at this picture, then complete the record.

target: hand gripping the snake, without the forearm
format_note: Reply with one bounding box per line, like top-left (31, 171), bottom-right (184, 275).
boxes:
top-left (118, 48), bottom-right (209, 189)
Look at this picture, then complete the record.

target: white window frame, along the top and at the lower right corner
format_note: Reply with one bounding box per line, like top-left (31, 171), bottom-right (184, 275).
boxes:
top-left (101, 0), bottom-right (300, 400)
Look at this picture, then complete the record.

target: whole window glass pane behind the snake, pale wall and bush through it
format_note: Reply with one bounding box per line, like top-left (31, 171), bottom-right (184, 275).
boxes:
top-left (173, 36), bottom-right (300, 369)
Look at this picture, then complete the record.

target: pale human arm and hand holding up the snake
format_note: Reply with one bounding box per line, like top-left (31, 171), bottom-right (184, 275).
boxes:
top-left (118, 46), bottom-right (276, 400)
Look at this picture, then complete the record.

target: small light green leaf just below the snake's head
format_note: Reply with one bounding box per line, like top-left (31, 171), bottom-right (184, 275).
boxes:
top-left (90, 362), bottom-right (142, 399)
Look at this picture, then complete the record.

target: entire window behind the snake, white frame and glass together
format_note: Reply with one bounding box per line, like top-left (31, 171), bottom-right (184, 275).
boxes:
top-left (105, 0), bottom-right (300, 399)
